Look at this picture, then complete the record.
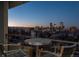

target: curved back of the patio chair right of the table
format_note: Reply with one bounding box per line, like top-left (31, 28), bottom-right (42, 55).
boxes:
top-left (60, 44), bottom-right (76, 57)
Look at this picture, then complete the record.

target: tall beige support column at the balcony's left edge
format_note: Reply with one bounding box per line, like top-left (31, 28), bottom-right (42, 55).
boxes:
top-left (0, 1), bottom-right (8, 50)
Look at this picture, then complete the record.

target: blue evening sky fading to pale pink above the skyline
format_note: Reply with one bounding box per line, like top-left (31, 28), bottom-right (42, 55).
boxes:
top-left (8, 1), bottom-right (79, 28)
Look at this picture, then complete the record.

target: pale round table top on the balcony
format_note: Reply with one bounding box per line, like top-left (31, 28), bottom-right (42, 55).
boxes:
top-left (25, 38), bottom-right (51, 46)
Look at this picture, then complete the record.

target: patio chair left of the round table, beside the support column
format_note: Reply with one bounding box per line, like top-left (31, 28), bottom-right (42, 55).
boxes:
top-left (0, 44), bottom-right (30, 57)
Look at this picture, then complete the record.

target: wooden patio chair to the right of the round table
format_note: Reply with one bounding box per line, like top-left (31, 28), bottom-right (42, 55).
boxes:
top-left (39, 44), bottom-right (76, 57)
